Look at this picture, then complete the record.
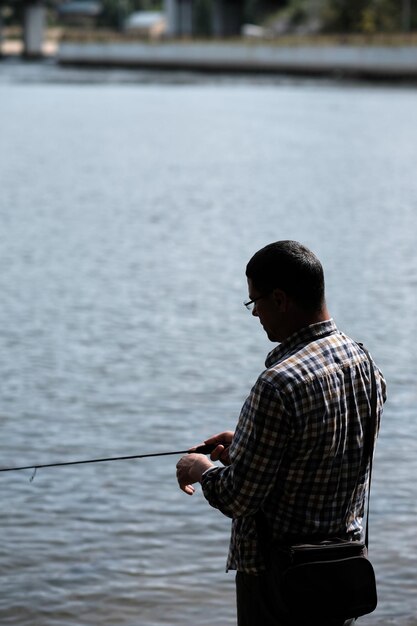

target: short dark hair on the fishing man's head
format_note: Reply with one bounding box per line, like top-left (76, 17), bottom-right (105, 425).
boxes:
top-left (246, 240), bottom-right (325, 312)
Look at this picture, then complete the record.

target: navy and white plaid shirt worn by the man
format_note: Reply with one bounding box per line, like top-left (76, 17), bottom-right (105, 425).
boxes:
top-left (201, 320), bottom-right (385, 573)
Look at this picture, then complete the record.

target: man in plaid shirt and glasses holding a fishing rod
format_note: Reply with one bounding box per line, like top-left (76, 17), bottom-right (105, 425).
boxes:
top-left (177, 241), bottom-right (385, 626)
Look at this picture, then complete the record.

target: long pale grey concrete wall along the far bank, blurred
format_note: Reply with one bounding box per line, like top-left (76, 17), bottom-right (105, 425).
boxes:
top-left (58, 42), bottom-right (417, 78)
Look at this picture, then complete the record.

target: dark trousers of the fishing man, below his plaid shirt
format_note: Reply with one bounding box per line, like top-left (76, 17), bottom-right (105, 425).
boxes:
top-left (236, 572), bottom-right (355, 626)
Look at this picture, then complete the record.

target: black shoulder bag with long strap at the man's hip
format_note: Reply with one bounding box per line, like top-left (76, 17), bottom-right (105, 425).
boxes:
top-left (258, 346), bottom-right (377, 623)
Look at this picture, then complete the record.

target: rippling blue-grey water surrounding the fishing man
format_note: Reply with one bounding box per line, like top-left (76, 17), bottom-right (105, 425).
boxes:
top-left (0, 56), bottom-right (417, 626)
